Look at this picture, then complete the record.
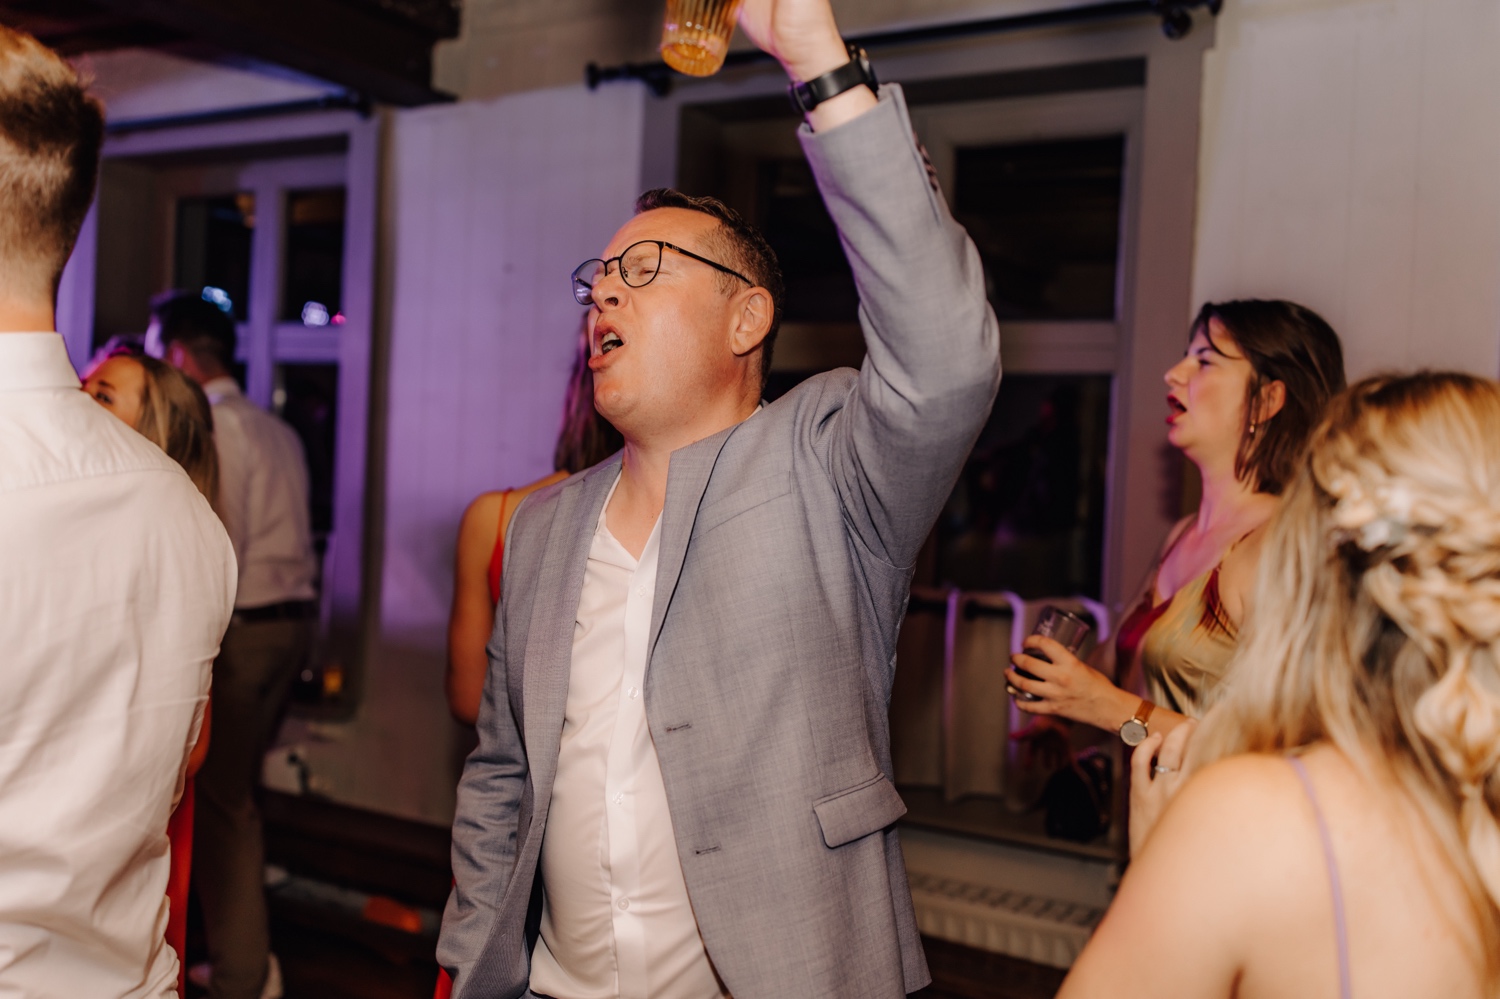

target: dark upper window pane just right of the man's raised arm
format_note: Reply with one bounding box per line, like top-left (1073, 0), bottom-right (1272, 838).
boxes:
top-left (954, 135), bottom-right (1125, 320)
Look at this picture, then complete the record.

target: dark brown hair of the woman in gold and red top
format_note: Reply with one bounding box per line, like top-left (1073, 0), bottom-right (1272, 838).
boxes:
top-left (1190, 299), bottom-right (1344, 497)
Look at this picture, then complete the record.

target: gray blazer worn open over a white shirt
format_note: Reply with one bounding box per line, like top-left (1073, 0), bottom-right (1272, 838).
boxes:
top-left (438, 87), bottom-right (999, 999)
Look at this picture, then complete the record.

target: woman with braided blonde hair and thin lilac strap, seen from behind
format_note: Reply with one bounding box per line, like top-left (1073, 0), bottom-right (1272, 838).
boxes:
top-left (1059, 374), bottom-right (1500, 999)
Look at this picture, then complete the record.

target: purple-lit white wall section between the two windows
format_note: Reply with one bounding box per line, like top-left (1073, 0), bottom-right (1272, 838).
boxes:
top-left (292, 87), bottom-right (645, 824)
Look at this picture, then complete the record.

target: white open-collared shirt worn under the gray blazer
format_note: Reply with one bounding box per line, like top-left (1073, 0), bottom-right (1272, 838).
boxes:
top-left (531, 480), bottom-right (728, 999)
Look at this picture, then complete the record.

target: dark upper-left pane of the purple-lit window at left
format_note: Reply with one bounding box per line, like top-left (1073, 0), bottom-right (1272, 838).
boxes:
top-left (173, 191), bottom-right (255, 321)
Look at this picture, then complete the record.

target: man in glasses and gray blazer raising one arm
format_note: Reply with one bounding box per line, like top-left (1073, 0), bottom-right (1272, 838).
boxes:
top-left (438, 0), bottom-right (999, 999)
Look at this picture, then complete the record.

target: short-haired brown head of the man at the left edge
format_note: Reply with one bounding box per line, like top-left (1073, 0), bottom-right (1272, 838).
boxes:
top-left (0, 26), bottom-right (104, 302)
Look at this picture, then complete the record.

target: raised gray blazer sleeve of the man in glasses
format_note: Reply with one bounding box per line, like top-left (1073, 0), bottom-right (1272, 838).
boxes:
top-left (801, 95), bottom-right (1001, 567)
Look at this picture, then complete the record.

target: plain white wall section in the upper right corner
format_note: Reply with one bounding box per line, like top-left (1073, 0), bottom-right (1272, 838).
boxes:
top-left (1194, 0), bottom-right (1500, 377)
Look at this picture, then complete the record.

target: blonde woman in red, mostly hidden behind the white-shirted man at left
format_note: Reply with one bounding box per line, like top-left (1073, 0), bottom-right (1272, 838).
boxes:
top-left (84, 347), bottom-right (219, 995)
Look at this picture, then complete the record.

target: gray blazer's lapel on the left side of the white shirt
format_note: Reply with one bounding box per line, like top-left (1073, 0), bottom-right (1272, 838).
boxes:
top-left (522, 456), bottom-right (620, 786)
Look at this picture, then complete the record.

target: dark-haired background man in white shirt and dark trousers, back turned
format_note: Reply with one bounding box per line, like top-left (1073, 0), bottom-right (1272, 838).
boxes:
top-left (146, 293), bottom-right (318, 999)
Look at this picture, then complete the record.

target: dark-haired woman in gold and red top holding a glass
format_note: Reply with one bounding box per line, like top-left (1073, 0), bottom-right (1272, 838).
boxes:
top-left (1007, 300), bottom-right (1344, 746)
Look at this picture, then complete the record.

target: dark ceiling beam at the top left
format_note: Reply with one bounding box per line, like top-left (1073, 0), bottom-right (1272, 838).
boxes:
top-left (92, 0), bottom-right (458, 107)
